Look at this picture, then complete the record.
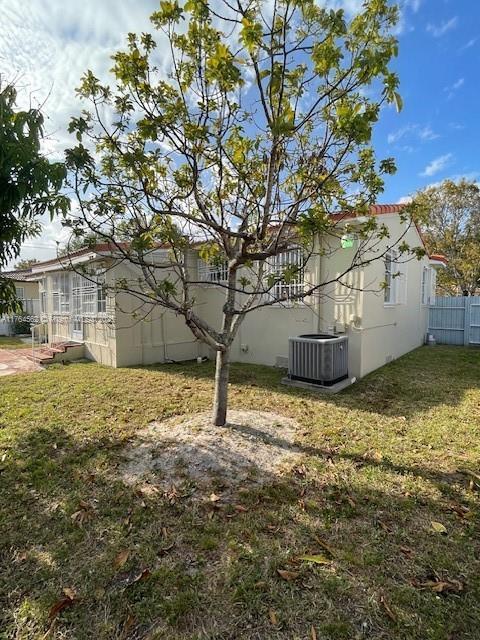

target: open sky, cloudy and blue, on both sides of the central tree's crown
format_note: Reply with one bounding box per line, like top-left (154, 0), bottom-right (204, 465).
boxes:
top-left (0, 0), bottom-right (480, 259)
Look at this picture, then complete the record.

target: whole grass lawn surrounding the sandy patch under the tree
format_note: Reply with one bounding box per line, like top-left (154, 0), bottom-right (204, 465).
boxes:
top-left (0, 346), bottom-right (480, 640)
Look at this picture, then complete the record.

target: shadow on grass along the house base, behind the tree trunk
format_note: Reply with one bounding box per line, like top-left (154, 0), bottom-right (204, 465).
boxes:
top-left (132, 346), bottom-right (480, 418)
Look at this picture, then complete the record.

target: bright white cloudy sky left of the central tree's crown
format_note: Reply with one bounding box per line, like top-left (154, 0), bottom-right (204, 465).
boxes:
top-left (0, 0), bottom-right (162, 260)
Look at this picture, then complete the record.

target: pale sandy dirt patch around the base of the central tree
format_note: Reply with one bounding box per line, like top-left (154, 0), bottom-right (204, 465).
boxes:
top-left (121, 411), bottom-right (299, 490)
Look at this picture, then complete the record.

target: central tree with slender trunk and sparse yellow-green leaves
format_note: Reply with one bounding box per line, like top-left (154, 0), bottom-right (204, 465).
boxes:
top-left (67, 0), bottom-right (414, 425)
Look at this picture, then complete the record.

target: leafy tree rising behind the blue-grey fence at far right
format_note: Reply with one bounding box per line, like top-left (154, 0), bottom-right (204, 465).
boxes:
top-left (414, 179), bottom-right (480, 295)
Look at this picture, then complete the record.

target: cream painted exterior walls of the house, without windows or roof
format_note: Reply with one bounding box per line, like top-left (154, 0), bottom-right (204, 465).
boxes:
top-left (28, 214), bottom-right (436, 377)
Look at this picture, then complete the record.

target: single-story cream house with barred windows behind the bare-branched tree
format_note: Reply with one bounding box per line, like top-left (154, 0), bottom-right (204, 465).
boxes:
top-left (25, 205), bottom-right (444, 377)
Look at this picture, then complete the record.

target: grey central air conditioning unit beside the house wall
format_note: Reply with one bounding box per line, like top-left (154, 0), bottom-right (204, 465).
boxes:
top-left (288, 333), bottom-right (348, 386)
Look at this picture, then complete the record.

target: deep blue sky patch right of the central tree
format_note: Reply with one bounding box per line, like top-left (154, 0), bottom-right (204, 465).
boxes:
top-left (374, 0), bottom-right (480, 202)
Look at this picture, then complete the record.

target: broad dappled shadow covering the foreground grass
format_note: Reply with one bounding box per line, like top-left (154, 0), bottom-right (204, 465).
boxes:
top-left (0, 416), bottom-right (480, 640)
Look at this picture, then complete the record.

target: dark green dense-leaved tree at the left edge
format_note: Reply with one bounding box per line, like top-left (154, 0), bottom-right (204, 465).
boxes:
top-left (0, 85), bottom-right (69, 314)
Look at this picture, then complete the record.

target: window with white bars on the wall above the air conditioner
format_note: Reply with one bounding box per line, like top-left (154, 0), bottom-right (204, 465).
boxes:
top-left (267, 247), bottom-right (305, 301)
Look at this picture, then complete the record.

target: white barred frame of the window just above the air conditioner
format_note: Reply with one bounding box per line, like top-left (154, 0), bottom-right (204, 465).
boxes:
top-left (266, 247), bottom-right (305, 306)
